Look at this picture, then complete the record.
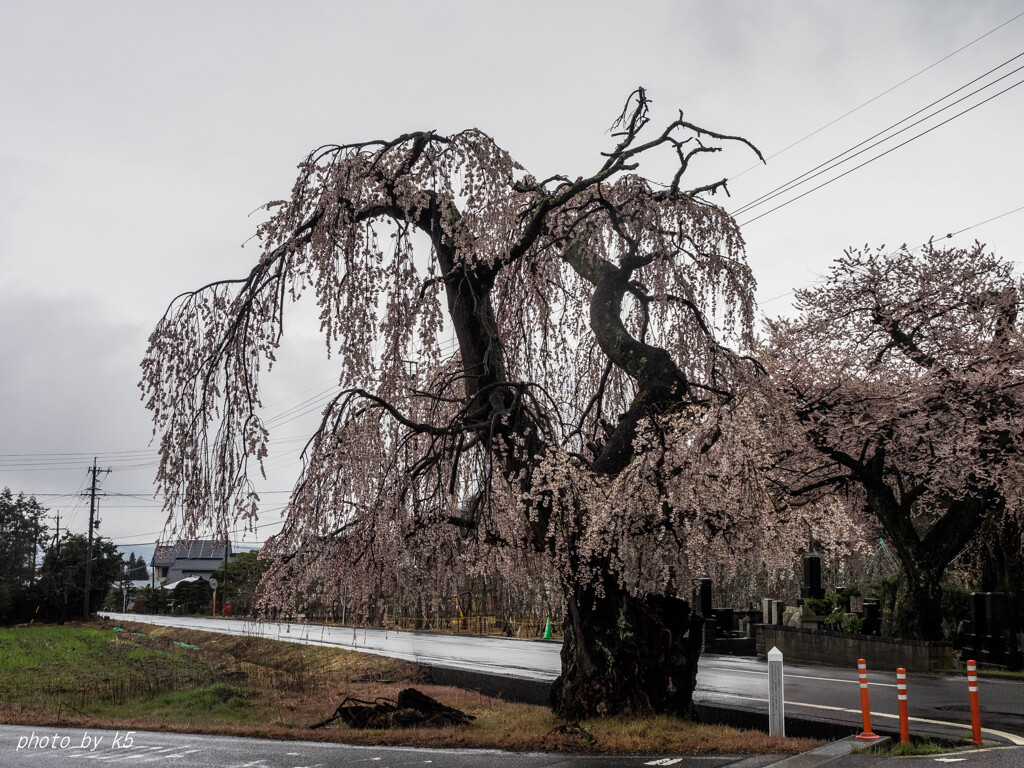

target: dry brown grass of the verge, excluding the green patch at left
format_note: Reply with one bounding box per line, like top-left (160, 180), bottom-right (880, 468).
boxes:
top-left (0, 624), bottom-right (821, 755)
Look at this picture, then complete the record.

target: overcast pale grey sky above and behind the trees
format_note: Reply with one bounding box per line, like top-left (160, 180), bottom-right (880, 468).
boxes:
top-left (0, 0), bottom-right (1024, 544)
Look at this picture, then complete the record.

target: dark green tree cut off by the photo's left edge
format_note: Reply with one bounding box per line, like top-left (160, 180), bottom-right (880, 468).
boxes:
top-left (0, 487), bottom-right (46, 622)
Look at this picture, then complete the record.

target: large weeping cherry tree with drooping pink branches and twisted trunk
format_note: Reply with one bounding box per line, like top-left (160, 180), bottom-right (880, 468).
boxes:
top-left (141, 89), bottom-right (806, 714)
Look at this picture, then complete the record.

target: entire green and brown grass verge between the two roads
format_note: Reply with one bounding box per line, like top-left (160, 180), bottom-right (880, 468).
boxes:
top-left (0, 623), bottom-right (821, 754)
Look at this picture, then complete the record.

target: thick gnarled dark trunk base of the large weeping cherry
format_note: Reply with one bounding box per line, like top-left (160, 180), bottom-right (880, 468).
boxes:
top-left (551, 578), bottom-right (703, 720)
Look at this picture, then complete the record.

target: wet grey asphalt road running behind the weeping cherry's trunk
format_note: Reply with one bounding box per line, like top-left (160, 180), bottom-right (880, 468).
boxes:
top-left (104, 613), bottom-right (1024, 744)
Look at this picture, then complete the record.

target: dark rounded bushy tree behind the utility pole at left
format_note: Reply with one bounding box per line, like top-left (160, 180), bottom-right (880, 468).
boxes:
top-left (40, 534), bottom-right (124, 622)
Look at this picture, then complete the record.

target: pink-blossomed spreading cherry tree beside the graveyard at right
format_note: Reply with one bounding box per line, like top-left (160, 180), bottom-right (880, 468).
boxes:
top-left (763, 244), bottom-right (1024, 639)
